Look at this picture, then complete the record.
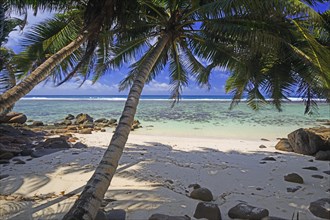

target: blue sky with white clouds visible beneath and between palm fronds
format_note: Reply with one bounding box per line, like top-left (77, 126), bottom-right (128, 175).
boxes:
top-left (7, 2), bottom-right (330, 95)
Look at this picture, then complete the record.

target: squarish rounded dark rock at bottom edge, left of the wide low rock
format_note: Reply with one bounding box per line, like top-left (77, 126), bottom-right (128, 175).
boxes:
top-left (194, 202), bottom-right (221, 220)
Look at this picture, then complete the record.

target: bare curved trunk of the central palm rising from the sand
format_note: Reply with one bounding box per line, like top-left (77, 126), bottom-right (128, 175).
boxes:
top-left (63, 35), bottom-right (169, 220)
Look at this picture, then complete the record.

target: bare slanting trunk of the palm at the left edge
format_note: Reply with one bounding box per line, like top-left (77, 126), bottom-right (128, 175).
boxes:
top-left (0, 33), bottom-right (89, 112)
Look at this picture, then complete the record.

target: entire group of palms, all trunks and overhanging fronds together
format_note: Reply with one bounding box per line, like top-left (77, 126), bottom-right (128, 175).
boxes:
top-left (0, 0), bottom-right (330, 219)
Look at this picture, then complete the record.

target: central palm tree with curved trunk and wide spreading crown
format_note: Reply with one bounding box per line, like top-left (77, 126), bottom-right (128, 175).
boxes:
top-left (64, 0), bottom-right (330, 219)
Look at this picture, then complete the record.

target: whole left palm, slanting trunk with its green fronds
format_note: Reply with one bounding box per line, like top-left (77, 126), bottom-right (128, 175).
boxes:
top-left (0, 0), bottom-right (136, 111)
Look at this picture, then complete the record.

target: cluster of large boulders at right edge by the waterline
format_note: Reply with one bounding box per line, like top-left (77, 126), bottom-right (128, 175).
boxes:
top-left (275, 127), bottom-right (330, 161)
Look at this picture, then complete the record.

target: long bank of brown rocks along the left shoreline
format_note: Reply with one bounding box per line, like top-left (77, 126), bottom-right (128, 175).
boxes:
top-left (0, 112), bottom-right (141, 164)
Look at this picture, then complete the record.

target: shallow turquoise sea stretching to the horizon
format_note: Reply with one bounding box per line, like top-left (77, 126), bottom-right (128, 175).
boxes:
top-left (14, 95), bottom-right (330, 140)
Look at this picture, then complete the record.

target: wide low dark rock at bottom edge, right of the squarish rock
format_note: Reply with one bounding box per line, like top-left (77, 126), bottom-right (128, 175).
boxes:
top-left (228, 203), bottom-right (269, 220)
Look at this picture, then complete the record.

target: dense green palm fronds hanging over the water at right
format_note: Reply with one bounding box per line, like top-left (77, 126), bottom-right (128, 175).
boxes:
top-left (199, 1), bottom-right (330, 113)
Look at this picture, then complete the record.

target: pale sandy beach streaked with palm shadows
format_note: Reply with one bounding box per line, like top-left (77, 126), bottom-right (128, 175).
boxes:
top-left (0, 132), bottom-right (330, 220)
